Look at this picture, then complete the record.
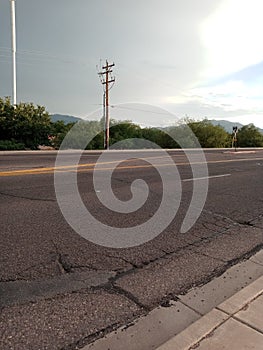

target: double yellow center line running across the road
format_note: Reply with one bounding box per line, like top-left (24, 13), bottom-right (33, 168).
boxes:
top-left (0, 156), bottom-right (263, 177)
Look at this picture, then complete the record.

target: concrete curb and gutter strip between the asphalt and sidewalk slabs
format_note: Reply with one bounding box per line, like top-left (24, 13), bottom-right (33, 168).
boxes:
top-left (83, 250), bottom-right (263, 350)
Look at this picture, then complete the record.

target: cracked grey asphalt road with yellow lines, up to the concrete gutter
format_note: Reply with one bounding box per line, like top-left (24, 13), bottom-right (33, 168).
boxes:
top-left (0, 149), bottom-right (263, 350)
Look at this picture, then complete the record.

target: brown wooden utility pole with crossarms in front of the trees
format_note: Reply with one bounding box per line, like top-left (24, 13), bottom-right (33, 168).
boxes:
top-left (98, 60), bottom-right (115, 149)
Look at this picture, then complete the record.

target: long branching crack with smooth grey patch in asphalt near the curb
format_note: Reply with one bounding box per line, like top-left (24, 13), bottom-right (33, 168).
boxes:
top-left (0, 212), bottom-right (263, 309)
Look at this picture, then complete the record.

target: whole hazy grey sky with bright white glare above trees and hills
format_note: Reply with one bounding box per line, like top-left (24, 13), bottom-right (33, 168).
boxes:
top-left (0, 0), bottom-right (263, 128)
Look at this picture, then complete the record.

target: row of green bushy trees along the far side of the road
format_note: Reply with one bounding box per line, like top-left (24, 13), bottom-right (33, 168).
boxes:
top-left (0, 97), bottom-right (263, 150)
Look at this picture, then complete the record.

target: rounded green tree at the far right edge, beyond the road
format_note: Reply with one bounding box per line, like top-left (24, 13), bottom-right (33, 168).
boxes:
top-left (237, 124), bottom-right (263, 147)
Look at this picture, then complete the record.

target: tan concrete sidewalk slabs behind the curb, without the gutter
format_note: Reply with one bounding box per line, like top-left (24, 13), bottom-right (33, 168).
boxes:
top-left (157, 276), bottom-right (263, 350)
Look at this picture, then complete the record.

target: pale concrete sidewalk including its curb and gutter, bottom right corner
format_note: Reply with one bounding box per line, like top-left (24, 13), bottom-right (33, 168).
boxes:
top-left (83, 250), bottom-right (263, 350)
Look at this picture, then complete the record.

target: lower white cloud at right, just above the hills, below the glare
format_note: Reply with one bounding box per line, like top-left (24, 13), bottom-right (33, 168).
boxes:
top-left (162, 76), bottom-right (263, 128)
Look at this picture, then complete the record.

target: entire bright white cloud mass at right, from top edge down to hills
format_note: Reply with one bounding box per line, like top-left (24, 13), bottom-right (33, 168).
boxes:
top-left (162, 0), bottom-right (263, 126)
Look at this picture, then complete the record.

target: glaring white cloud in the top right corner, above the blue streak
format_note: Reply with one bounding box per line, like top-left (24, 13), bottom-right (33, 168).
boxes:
top-left (201, 0), bottom-right (263, 77)
